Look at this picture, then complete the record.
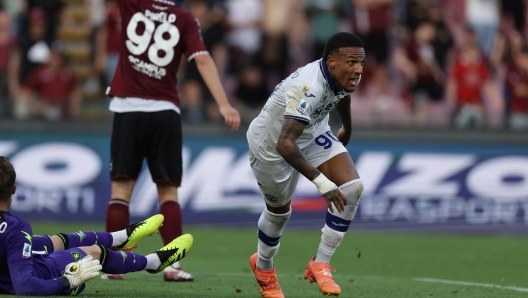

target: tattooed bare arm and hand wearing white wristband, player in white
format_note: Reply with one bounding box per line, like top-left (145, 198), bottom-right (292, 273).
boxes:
top-left (276, 119), bottom-right (346, 213)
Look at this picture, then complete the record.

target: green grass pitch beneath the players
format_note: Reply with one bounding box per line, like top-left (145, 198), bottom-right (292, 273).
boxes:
top-left (25, 222), bottom-right (528, 298)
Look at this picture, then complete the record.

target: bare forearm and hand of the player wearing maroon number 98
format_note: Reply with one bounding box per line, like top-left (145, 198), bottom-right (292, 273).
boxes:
top-left (194, 55), bottom-right (240, 130)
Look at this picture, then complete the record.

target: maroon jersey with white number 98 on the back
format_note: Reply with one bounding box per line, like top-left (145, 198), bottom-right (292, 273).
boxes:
top-left (107, 0), bottom-right (207, 107)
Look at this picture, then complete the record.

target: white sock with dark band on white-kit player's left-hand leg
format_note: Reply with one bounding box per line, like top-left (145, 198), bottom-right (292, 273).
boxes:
top-left (257, 209), bottom-right (291, 270)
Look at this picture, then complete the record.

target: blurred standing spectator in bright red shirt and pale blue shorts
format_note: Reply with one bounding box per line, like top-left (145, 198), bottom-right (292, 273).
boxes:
top-left (446, 29), bottom-right (504, 128)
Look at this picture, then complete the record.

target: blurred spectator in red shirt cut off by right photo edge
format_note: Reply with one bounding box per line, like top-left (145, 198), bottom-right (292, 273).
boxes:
top-left (506, 48), bottom-right (528, 130)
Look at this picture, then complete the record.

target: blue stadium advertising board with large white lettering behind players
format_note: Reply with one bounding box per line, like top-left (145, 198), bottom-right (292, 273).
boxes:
top-left (0, 133), bottom-right (528, 229)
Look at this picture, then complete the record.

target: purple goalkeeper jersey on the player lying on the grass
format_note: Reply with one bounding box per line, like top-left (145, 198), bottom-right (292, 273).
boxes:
top-left (0, 211), bottom-right (64, 296)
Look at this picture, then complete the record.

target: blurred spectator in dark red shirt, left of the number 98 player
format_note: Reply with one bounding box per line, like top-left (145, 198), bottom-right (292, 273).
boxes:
top-left (21, 42), bottom-right (81, 121)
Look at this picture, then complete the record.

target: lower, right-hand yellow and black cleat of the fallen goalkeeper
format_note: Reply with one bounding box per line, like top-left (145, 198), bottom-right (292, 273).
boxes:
top-left (147, 234), bottom-right (194, 274)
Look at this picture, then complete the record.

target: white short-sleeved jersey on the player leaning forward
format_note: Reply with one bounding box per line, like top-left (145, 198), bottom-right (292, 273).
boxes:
top-left (247, 59), bottom-right (349, 163)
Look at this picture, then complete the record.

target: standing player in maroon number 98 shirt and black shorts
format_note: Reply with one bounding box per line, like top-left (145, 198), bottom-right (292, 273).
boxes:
top-left (106, 0), bottom-right (240, 281)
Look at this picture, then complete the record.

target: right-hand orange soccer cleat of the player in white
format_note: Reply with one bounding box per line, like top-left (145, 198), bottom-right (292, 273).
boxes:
top-left (304, 257), bottom-right (341, 296)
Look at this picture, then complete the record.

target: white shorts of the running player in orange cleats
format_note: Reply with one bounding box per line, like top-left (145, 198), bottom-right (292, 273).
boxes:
top-left (249, 130), bottom-right (348, 207)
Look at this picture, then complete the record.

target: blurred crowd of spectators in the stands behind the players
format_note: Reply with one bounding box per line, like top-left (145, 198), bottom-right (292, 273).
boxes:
top-left (0, 0), bottom-right (528, 131)
